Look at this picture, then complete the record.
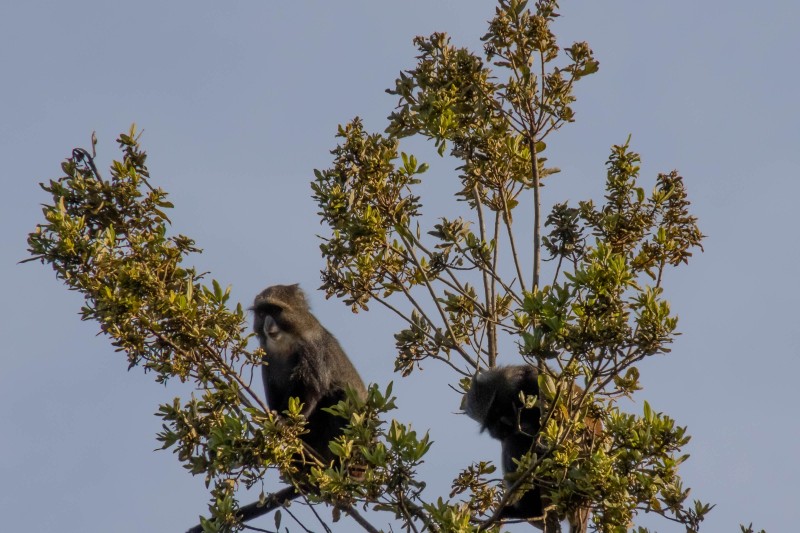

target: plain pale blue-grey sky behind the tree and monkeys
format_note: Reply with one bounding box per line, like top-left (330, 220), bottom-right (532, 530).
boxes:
top-left (0, 0), bottom-right (800, 533)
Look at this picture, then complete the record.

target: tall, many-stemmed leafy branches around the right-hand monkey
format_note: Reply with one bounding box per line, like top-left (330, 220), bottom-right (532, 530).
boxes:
top-left (312, 0), bottom-right (710, 531)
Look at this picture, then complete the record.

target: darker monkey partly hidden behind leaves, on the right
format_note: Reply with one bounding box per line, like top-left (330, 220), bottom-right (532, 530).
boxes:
top-left (461, 365), bottom-right (594, 533)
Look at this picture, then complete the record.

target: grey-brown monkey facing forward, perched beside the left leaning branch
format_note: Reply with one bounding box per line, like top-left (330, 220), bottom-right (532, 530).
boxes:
top-left (251, 284), bottom-right (367, 461)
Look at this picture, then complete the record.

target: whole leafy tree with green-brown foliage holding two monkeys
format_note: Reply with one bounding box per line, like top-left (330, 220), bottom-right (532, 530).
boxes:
top-left (29, 0), bottom-right (756, 531)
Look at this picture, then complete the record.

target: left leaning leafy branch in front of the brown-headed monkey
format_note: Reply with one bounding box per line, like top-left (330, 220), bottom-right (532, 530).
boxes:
top-left (28, 128), bottom-right (430, 531)
